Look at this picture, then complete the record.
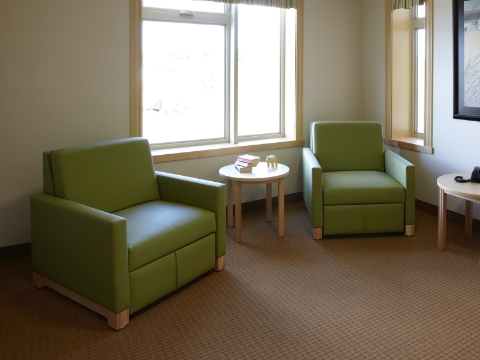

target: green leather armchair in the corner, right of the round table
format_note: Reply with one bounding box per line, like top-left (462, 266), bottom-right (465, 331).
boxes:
top-left (303, 121), bottom-right (415, 239)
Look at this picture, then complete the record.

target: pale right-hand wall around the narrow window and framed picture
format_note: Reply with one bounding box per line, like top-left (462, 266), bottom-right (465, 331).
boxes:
top-left (362, 0), bottom-right (480, 219)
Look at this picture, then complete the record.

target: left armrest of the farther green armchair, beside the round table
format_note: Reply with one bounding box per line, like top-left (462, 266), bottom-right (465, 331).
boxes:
top-left (302, 148), bottom-right (323, 228)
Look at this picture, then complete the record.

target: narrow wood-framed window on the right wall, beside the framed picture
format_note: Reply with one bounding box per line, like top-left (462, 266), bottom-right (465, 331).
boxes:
top-left (385, 0), bottom-right (433, 153)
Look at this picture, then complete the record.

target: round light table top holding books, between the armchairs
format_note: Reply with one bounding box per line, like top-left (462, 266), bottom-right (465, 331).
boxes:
top-left (218, 162), bottom-right (290, 182)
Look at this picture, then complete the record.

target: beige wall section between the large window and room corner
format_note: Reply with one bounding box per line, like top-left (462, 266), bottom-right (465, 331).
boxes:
top-left (304, 0), bottom-right (363, 145)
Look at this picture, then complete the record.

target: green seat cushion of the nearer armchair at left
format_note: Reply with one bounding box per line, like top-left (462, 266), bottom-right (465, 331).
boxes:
top-left (115, 200), bottom-right (216, 271)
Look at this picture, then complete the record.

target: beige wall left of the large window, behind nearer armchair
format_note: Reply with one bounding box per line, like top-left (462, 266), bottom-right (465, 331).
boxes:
top-left (0, 0), bottom-right (130, 247)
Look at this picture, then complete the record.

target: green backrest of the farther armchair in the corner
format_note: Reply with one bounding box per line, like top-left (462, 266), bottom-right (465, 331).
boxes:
top-left (310, 121), bottom-right (385, 171)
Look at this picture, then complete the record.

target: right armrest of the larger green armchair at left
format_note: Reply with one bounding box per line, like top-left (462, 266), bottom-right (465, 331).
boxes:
top-left (156, 171), bottom-right (227, 258)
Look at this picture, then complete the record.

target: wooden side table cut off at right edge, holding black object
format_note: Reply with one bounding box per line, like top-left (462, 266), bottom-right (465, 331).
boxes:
top-left (437, 174), bottom-right (480, 250)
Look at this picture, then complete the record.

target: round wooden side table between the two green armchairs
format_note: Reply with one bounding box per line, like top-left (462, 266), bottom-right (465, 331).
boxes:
top-left (218, 162), bottom-right (290, 242)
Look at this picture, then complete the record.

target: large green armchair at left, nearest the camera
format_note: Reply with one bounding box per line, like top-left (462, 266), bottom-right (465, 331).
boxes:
top-left (30, 138), bottom-right (226, 330)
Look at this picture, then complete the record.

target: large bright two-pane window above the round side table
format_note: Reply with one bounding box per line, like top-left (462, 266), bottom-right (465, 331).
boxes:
top-left (131, 0), bottom-right (303, 160)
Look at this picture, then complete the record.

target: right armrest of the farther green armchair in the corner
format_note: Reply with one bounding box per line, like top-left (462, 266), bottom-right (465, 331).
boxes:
top-left (385, 149), bottom-right (415, 225)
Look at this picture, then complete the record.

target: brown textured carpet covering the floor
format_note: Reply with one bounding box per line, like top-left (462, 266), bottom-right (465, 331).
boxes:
top-left (0, 203), bottom-right (480, 359)
